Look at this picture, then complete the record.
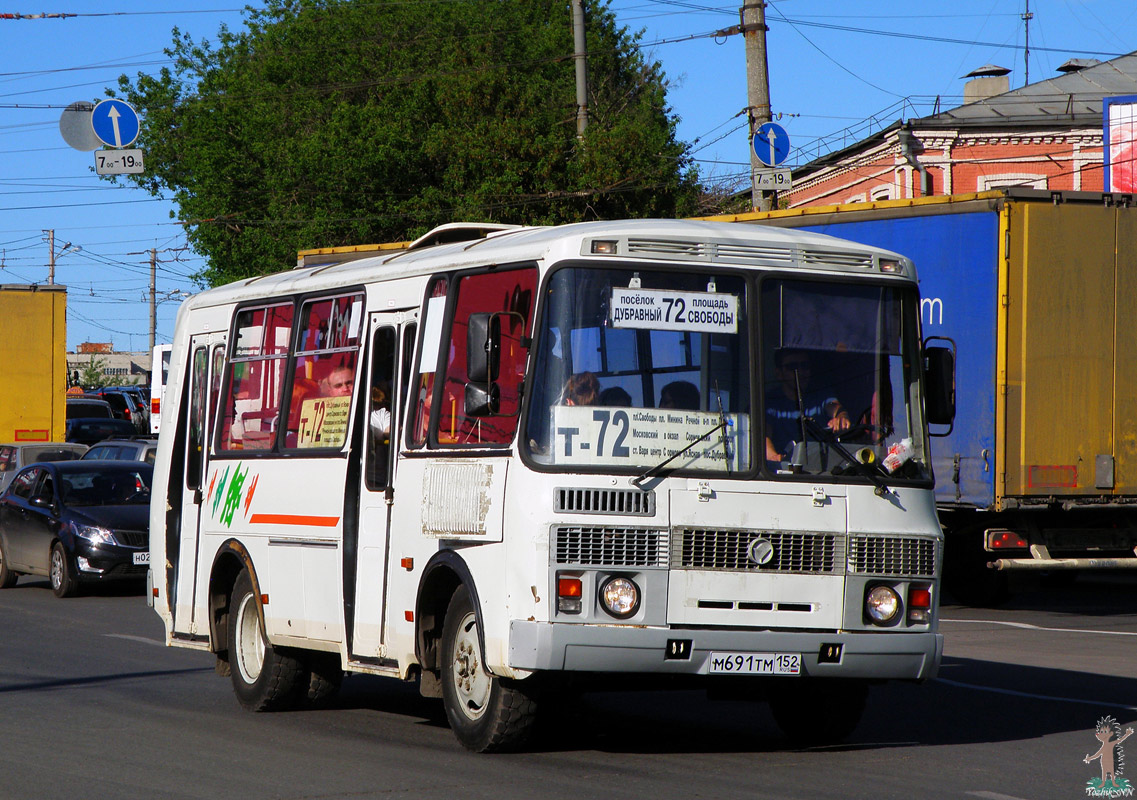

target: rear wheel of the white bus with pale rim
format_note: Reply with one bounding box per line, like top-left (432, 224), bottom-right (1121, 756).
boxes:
top-left (229, 569), bottom-right (305, 711)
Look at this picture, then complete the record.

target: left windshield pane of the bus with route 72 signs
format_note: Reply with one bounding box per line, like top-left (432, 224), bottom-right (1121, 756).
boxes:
top-left (524, 267), bottom-right (752, 473)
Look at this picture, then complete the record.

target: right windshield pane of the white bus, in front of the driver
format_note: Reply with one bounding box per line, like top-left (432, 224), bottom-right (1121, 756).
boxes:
top-left (760, 277), bottom-right (930, 481)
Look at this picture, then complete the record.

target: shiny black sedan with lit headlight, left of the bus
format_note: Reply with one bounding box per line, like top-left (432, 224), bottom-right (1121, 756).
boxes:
top-left (0, 460), bottom-right (153, 598)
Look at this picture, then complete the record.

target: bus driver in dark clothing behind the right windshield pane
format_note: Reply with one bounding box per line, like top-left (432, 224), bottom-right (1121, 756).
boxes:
top-left (766, 348), bottom-right (852, 461)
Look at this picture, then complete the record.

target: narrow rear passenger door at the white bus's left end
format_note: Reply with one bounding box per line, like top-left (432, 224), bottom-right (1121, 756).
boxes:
top-left (167, 333), bottom-right (227, 635)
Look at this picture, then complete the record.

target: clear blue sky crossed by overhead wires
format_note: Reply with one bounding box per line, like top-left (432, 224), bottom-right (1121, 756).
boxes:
top-left (0, 0), bottom-right (1137, 351)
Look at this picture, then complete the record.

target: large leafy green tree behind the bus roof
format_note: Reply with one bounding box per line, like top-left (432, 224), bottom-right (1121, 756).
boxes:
top-left (113, 0), bottom-right (697, 284)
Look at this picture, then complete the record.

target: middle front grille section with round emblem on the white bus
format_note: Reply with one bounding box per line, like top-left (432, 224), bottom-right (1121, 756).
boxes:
top-left (671, 528), bottom-right (843, 574)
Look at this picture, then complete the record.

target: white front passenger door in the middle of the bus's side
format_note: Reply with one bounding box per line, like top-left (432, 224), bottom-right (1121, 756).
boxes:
top-left (343, 310), bottom-right (417, 660)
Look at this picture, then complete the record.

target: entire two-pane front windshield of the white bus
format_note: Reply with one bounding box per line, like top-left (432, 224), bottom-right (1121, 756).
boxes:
top-left (523, 267), bottom-right (929, 483)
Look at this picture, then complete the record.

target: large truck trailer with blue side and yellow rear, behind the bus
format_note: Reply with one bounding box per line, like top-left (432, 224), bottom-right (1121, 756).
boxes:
top-left (717, 190), bottom-right (1137, 605)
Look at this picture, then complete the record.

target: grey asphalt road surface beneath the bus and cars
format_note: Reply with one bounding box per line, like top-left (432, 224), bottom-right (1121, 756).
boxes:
top-left (0, 576), bottom-right (1137, 800)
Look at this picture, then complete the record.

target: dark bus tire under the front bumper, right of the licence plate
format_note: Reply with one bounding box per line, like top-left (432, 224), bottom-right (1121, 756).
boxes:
top-left (770, 678), bottom-right (869, 745)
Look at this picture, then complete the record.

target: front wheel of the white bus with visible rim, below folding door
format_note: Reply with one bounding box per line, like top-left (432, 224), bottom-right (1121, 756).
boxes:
top-left (441, 586), bottom-right (537, 752)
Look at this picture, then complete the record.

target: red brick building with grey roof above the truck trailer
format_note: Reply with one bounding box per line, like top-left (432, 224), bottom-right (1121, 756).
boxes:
top-left (779, 52), bottom-right (1137, 208)
